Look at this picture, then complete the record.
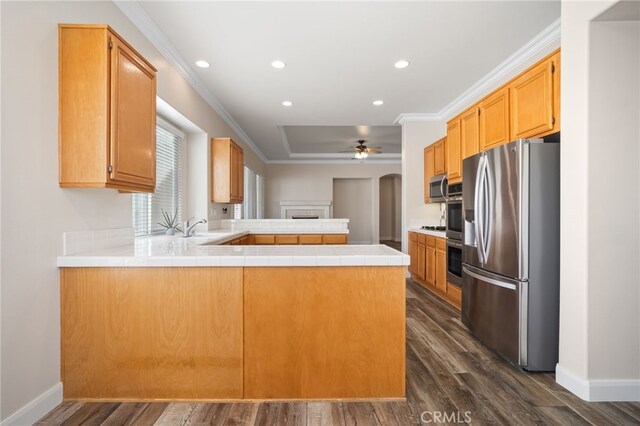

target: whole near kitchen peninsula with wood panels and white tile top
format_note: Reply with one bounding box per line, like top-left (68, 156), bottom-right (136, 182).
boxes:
top-left (58, 223), bottom-right (409, 400)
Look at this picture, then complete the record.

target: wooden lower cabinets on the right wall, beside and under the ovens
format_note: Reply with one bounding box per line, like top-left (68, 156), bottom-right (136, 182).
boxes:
top-left (409, 232), bottom-right (462, 309)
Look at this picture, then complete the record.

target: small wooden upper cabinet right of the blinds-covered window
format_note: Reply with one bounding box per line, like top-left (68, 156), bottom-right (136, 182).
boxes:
top-left (211, 138), bottom-right (244, 204)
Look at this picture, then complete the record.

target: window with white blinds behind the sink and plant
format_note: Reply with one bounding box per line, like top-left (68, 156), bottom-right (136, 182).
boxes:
top-left (132, 117), bottom-right (184, 236)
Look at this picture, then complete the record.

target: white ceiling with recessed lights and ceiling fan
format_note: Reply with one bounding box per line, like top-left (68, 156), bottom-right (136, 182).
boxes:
top-left (140, 1), bottom-right (560, 160)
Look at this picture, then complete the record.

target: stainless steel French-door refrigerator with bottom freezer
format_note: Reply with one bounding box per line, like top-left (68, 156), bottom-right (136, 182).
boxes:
top-left (462, 139), bottom-right (560, 371)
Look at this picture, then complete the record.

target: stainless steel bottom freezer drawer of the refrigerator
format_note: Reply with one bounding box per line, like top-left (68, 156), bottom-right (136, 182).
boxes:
top-left (462, 265), bottom-right (527, 366)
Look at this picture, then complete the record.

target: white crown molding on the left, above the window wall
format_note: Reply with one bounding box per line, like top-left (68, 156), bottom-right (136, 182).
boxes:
top-left (114, 0), bottom-right (267, 163)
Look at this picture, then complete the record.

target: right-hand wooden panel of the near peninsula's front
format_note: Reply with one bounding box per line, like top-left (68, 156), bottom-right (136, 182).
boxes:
top-left (244, 266), bottom-right (406, 399)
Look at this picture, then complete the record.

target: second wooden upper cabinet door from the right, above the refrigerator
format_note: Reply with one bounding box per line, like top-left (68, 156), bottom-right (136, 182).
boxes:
top-left (478, 87), bottom-right (511, 151)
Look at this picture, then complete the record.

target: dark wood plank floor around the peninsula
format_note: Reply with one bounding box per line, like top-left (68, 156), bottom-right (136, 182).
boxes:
top-left (39, 280), bottom-right (640, 426)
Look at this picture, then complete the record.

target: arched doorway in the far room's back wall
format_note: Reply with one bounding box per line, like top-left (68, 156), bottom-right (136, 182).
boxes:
top-left (378, 173), bottom-right (402, 250)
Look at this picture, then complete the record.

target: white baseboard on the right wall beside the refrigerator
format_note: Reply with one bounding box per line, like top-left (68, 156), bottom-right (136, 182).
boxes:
top-left (556, 364), bottom-right (640, 402)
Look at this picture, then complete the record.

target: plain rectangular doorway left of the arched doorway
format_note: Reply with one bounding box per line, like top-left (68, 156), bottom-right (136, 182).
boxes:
top-left (333, 178), bottom-right (373, 244)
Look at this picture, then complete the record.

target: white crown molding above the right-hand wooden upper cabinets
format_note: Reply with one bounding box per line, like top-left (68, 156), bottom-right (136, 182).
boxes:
top-left (436, 18), bottom-right (560, 121)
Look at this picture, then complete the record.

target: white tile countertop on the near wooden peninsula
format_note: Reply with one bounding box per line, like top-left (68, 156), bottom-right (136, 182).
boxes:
top-left (57, 231), bottom-right (409, 268)
